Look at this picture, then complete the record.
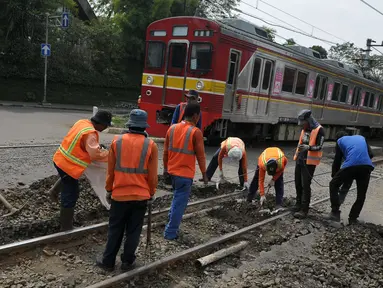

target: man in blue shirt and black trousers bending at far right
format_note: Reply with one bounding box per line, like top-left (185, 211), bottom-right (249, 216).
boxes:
top-left (329, 132), bottom-right (374, 224)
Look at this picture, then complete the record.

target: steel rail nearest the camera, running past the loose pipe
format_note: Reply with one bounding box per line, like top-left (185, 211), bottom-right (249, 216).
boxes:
top-left (87, 176), bottom-right (383, 288)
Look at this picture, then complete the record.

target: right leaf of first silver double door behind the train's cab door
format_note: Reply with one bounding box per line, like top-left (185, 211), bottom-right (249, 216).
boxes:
top-left (256, 58), bottom-right (274, 116)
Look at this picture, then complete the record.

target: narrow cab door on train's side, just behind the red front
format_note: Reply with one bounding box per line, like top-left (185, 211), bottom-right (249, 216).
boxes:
top-left (223, 49), bottom-right (241, 113)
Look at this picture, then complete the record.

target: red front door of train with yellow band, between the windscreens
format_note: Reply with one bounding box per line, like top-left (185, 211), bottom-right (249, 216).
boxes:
top-left (162, 40), bottom-right (189, 105)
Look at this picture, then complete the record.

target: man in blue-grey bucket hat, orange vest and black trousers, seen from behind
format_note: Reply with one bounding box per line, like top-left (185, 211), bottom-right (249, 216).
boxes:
top-left (96, 109), bottom-right (158, 271)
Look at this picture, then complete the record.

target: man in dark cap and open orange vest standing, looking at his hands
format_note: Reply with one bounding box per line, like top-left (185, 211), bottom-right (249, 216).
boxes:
top-left (294, 110), bottom-right (324, 218)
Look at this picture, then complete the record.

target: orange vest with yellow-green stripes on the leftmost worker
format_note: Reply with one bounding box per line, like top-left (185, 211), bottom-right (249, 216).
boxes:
top-left (53, 120), bottom-right (98, 179)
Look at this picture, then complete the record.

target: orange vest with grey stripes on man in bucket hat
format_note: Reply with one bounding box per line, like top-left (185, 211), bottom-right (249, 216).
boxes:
top-left (112, 133), bottom-right (154, 200)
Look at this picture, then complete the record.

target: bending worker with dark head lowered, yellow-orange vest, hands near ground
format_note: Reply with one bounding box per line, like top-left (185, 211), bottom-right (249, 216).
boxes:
top-left (247, 147), bottom-right (287, 210)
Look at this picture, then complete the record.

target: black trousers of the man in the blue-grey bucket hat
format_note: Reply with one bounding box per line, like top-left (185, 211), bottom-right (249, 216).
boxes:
top-left (102, 200), bottom-right (148, 267)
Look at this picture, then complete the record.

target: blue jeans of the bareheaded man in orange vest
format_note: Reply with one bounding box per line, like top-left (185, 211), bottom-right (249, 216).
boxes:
top-left (164, 175), bottom-right (193, 240)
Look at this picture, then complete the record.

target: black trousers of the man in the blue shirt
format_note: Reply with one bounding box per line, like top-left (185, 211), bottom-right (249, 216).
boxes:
top-left (330, 165), bottom-right (373, 220)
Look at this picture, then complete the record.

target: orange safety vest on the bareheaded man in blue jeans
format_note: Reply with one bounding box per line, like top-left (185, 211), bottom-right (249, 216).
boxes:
top-left (167, 121), bottom-right (198, 179)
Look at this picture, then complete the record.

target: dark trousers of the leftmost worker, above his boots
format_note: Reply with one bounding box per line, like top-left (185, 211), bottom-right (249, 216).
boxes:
top-left (53, 163), bottom-right (80, 208)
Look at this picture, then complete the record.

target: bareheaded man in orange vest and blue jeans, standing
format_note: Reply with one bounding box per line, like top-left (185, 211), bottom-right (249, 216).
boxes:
top-left (163, 104), bottom-right (208, 240)
